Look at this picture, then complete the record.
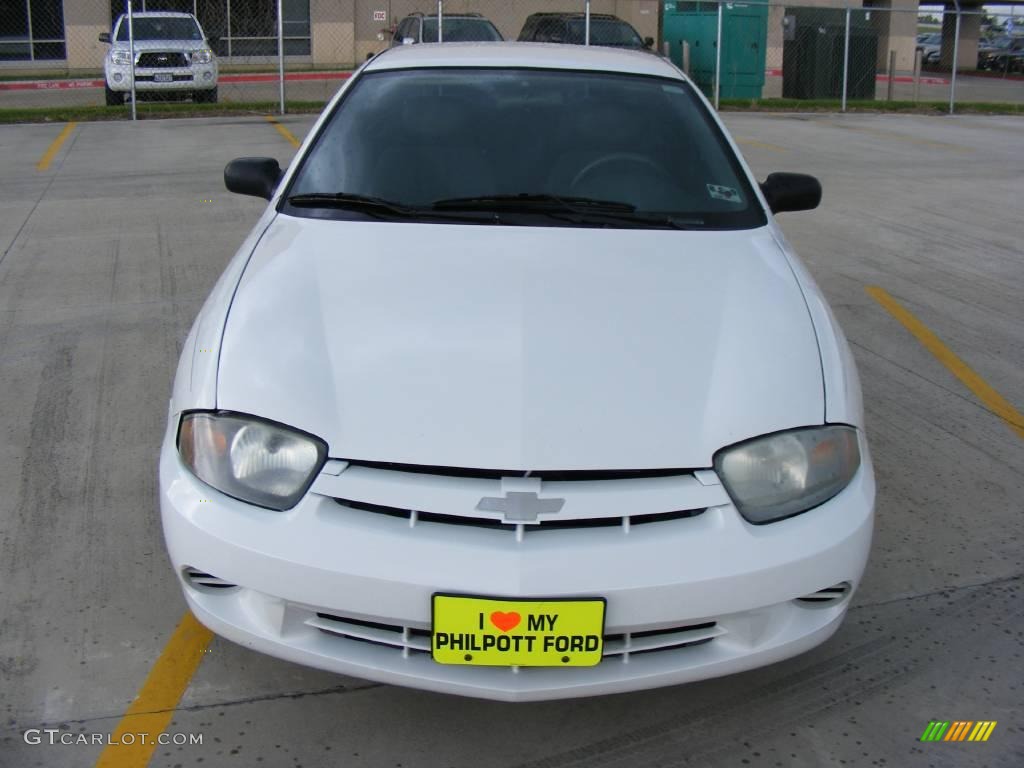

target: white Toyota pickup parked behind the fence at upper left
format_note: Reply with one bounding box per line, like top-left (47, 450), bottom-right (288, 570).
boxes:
top-left (99, 11), bottom-right (218, 106)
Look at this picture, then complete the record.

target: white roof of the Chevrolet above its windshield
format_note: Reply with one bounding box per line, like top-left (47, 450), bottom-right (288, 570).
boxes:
top-left (365, 42), bottom-right (685, 80)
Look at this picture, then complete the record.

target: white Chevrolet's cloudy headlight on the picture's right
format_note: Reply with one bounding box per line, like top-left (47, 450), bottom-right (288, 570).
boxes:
top-left (715, 425), bottom-right (860, 523)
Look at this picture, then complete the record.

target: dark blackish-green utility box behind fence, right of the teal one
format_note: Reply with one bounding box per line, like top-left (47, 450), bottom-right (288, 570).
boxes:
top-left (782, 8), bottom-right (879, 99)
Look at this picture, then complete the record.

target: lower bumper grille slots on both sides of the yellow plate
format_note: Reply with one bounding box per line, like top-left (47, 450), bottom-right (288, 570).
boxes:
top-left (305, 612), bottom-right (725, 664)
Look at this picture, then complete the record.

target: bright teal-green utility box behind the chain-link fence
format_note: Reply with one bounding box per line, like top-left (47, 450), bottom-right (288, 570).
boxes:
top-left (662, 2), bottom-right (768, 98)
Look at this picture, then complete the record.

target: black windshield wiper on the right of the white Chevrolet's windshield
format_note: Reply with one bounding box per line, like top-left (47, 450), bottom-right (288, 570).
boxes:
top-left (431, 193), bottom-right (703, 229)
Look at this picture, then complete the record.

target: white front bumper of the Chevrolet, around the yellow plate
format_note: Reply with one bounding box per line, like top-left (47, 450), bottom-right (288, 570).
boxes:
top-left (161, 430), bottom-right (874, 700)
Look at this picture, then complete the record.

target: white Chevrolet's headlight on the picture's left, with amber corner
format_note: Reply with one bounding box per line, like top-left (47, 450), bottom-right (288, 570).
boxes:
top-left (178, 412), bottom-right (327, 511)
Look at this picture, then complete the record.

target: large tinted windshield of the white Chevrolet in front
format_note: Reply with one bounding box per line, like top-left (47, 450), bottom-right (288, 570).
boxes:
top-left (286, 68), bottom-right (765, 228)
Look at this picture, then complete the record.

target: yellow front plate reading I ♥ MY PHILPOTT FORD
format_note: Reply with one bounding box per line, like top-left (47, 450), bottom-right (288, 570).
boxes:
top-left (431, 594), bottom-right (604, 667)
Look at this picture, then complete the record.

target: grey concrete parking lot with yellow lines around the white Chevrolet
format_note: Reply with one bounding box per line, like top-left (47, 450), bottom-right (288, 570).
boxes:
top-left (0, 114), bottom-right (1024, 768)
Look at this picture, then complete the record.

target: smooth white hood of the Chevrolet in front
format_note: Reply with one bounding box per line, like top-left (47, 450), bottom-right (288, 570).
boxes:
top-left (217, 215), bottom-right (824, 470)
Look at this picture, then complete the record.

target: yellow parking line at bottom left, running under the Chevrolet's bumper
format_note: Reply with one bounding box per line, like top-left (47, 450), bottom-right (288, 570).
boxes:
top-left (96, 612), bottom-right (213, 768)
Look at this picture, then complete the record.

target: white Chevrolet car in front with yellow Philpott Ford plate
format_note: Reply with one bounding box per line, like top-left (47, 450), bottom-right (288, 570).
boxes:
top-left (160, 43), bottom-right (874, 700)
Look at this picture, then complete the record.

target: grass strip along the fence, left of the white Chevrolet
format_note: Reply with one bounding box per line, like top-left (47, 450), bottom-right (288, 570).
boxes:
top-left (0, 101), bottom-right (325, 123)
